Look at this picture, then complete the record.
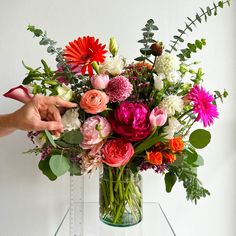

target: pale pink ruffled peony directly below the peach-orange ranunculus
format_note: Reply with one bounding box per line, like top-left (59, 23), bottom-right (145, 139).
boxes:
top-left (80, 115), bottom-right (111, 152)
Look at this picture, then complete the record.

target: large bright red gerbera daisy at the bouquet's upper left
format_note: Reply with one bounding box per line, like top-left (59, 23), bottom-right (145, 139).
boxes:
top-left (64, 36), bottom-right (107, 76)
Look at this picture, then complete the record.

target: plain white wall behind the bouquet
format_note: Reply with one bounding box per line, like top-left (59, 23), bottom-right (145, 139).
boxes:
top-left (0, 0), bottom-right (236, 236)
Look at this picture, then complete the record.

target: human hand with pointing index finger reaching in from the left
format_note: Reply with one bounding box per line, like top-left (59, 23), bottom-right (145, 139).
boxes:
top-left (10, 95), bottom-right (77, 136)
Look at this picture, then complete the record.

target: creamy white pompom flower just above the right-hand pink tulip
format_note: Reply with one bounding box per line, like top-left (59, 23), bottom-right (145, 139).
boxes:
top-left (159, 95), bottom-right (184, 117)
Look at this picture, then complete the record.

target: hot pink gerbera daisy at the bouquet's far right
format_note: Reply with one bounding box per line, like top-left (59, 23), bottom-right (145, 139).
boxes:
top-left (187, 85), bottom-right (219, 127)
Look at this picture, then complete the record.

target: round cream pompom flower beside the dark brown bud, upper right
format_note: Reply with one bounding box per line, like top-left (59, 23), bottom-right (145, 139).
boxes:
top-left (155, 53), bottom-right (180, 76)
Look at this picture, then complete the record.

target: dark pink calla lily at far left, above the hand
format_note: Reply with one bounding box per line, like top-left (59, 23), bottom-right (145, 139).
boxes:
top-left (3, 85), bottom-right (33, 103)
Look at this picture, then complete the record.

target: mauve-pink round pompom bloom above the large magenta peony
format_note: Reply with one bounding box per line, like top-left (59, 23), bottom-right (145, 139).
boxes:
top-left (106, 76), bottom-right (133, 102)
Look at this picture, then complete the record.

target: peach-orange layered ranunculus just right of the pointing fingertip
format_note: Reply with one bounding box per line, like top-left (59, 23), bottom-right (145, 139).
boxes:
top-left (80, 89), bottom-right (109, 114)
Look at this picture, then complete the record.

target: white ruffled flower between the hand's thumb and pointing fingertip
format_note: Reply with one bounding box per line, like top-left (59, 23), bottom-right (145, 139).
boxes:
top-left (62, 108), bottom-right (81, 131)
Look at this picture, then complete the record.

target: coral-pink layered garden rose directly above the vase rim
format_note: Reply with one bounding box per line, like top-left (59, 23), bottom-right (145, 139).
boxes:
top-left (102, 139), bottom-right (134, 167)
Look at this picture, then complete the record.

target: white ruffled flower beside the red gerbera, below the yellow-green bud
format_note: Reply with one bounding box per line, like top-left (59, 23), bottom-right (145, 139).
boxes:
top-left (100, 55), bottom-right (125, 76)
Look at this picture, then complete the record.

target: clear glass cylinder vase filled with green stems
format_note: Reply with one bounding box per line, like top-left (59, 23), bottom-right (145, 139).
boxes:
top-left (99, 165), bottom-right (143, 227)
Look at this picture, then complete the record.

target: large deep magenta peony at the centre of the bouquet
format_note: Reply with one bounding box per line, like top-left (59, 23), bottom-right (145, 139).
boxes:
top-left (109, 101), bottom-right (151, 142)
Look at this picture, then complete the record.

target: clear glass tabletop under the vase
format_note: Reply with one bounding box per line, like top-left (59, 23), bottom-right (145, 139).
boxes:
top-left (55, 202), bottom-right (175, 236)
